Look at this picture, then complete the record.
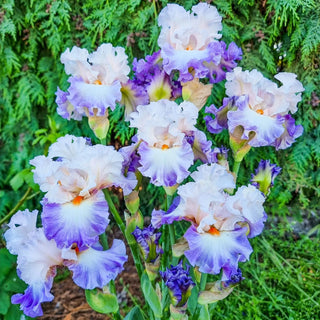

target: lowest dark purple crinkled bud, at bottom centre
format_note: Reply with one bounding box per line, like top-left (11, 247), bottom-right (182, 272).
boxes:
top-left (160, 260), bottom-right (195, 307)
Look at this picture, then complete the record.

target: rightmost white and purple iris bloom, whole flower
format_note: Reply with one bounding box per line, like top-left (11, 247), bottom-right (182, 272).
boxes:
top-left (205, 68), bottom-right (304, 150)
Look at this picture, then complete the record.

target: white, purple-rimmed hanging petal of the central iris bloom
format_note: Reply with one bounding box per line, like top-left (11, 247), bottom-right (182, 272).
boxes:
top-left (138, 142), bottom-right (194, 187)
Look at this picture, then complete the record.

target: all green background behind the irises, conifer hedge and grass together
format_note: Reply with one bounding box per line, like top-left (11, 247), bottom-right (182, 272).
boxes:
top-left (0, 0), bottom-right (320, 319)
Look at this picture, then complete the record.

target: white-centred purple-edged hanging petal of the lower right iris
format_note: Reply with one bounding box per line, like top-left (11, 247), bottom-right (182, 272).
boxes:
top-left (184, 226), bottom-right (252, 274)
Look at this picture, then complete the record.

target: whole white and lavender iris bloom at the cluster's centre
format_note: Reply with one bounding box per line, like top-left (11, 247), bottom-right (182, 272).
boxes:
top-left (130, 100), bottom-right (211, 187)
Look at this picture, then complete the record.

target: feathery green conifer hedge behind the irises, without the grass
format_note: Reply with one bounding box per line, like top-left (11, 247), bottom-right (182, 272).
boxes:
top-left (0, 0), bottom-right (320, 218)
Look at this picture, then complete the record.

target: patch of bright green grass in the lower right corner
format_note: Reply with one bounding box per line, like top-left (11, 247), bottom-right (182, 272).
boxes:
top-left (214, 220), bottom-right (320, 320)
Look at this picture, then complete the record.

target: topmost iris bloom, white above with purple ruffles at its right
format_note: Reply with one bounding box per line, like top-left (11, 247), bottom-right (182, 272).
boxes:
top-left (158, 3), bottom-right (242, 83)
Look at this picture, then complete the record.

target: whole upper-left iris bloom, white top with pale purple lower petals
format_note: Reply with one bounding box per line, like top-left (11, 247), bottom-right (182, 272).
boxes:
top-left (56, 43), bottom-right (130, 120)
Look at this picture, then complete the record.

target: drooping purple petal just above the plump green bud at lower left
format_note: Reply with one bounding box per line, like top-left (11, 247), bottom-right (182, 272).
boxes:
top-left (65, 239), bottom-right (128, 289)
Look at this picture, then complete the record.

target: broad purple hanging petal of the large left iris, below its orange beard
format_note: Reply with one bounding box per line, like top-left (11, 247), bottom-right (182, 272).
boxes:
top-left (42, 191), bottom-right (109, 248)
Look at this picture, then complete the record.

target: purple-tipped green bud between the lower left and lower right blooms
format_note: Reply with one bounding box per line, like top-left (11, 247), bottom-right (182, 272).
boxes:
top-left (132, 225), bottom-right (163, 263)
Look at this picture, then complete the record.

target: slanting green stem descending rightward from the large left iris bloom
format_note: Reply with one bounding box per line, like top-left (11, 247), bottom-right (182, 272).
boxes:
top-left (103, 189), bottom-right (143, 278)
